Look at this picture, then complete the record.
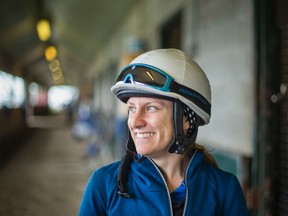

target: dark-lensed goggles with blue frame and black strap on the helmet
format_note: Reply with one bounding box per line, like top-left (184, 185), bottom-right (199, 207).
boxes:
top-left (116, 64), bottom-right (211, 114)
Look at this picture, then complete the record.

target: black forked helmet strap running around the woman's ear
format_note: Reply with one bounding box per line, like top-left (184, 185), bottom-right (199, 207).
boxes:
top-left (168, 102), bottom-right (199, 154)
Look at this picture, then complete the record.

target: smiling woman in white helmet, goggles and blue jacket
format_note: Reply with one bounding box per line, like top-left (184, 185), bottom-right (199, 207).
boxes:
top-left (79, 49), bottom-right (248, 216)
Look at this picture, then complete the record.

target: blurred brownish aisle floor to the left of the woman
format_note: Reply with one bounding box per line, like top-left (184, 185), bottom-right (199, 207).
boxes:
top-left (0, 115), bottom-right (114, 216)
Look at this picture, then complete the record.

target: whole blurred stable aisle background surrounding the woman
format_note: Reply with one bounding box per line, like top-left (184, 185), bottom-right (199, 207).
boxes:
top-left (0, 0), bottom-right (288, 216)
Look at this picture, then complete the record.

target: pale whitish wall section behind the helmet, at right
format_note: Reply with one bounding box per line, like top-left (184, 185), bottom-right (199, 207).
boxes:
top-left (196, 0), bottom-right (256, 156)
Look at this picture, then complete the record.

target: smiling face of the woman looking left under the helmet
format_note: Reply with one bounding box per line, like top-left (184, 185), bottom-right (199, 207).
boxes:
top-left (127, 97), bottom-right (174, 157)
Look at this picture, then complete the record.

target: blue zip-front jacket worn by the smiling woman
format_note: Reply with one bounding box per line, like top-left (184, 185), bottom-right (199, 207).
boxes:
top-left (79, 152), bottom-right (248, 216)
